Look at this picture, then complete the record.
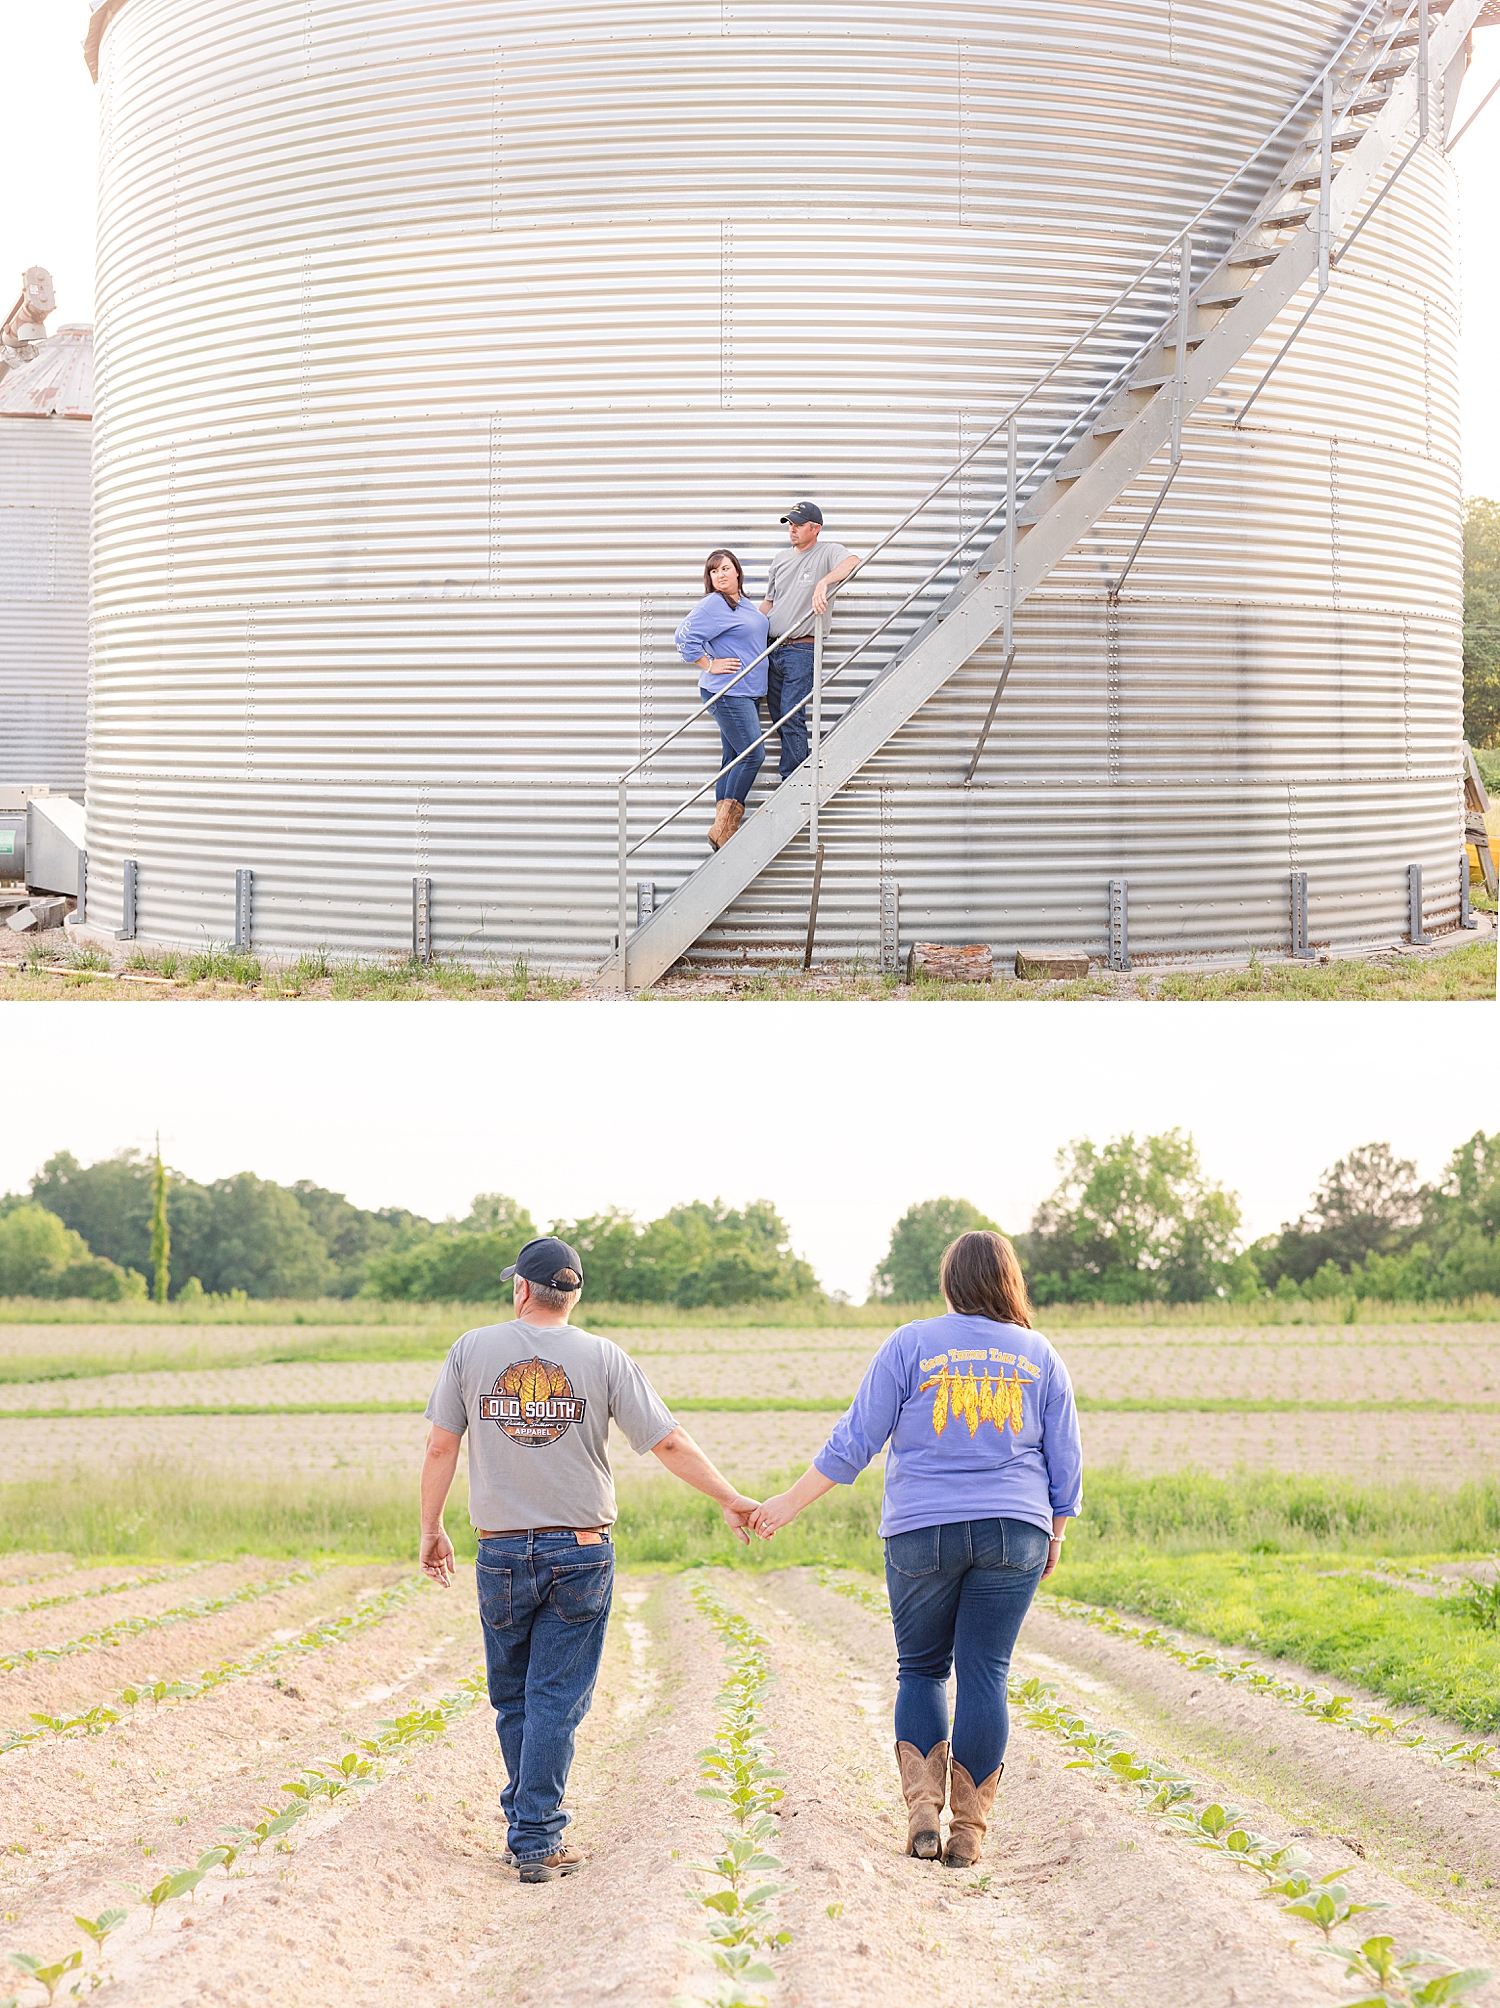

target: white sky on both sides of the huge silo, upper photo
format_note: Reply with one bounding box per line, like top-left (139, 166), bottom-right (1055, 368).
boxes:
top-left (0, 0), bottom-right (1500, 498)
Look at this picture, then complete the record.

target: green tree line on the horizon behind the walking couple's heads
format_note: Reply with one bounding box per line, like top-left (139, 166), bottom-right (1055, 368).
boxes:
top-left (0, 1131), bottom-right (1500, 1309)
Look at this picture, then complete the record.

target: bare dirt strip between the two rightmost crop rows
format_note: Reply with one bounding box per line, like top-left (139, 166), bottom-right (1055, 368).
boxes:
top-left (1024, 1610), bottom-right (1500, 1935)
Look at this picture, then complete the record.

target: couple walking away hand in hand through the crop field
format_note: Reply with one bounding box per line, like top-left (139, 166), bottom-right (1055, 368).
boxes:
top-left (422, 1233), bottom-right (1082, 1881)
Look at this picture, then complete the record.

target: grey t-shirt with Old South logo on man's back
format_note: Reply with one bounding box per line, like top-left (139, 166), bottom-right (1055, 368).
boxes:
top-left (428, 1319), bottom-right (677, 1534)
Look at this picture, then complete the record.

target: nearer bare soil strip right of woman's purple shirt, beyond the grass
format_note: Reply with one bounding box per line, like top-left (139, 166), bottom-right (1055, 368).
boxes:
top-left (1076, 1412), bottom-right (1500, 1486)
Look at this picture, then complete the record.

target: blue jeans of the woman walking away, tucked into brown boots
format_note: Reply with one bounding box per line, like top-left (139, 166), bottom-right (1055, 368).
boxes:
top-left (886, 1520), bottom-right (1048, 1785)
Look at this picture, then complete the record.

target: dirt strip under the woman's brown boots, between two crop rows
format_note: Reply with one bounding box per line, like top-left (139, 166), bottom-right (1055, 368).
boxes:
top-left (769, 1570), bottom-right (1357, 2008)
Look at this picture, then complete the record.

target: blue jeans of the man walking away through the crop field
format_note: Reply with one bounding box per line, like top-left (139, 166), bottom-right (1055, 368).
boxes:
top-left (478, 1534), bottom-right (614, 1861)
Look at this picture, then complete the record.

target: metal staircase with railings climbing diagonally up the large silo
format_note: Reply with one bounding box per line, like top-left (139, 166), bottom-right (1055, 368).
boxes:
top-left (600, 0), bottom-right (1486, 988)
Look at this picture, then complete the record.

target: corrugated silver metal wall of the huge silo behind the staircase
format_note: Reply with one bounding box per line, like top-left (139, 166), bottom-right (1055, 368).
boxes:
top-left (90, 0), bottom-right (1462, 964)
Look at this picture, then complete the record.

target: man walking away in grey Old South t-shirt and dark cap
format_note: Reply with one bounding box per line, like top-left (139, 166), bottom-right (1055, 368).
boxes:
top-left (422, 1235), bottom-right (757, 1884)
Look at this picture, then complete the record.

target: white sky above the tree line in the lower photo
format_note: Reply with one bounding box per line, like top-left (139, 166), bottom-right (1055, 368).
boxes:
top-left (0, 1004), bottom-right (1500, 1299)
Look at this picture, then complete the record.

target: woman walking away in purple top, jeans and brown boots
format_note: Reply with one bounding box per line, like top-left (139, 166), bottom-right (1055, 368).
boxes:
top-left (749, 1233), bottom-right (1082, 1869)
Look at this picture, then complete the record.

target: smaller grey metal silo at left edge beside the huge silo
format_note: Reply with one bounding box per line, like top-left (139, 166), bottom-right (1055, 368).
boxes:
top-left (0, 325), bottom-right (94, 795)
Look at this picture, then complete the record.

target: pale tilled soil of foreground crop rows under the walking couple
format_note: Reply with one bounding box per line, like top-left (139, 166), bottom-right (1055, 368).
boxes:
top-left (11, 1570), bottom-right (1496, 2008)
